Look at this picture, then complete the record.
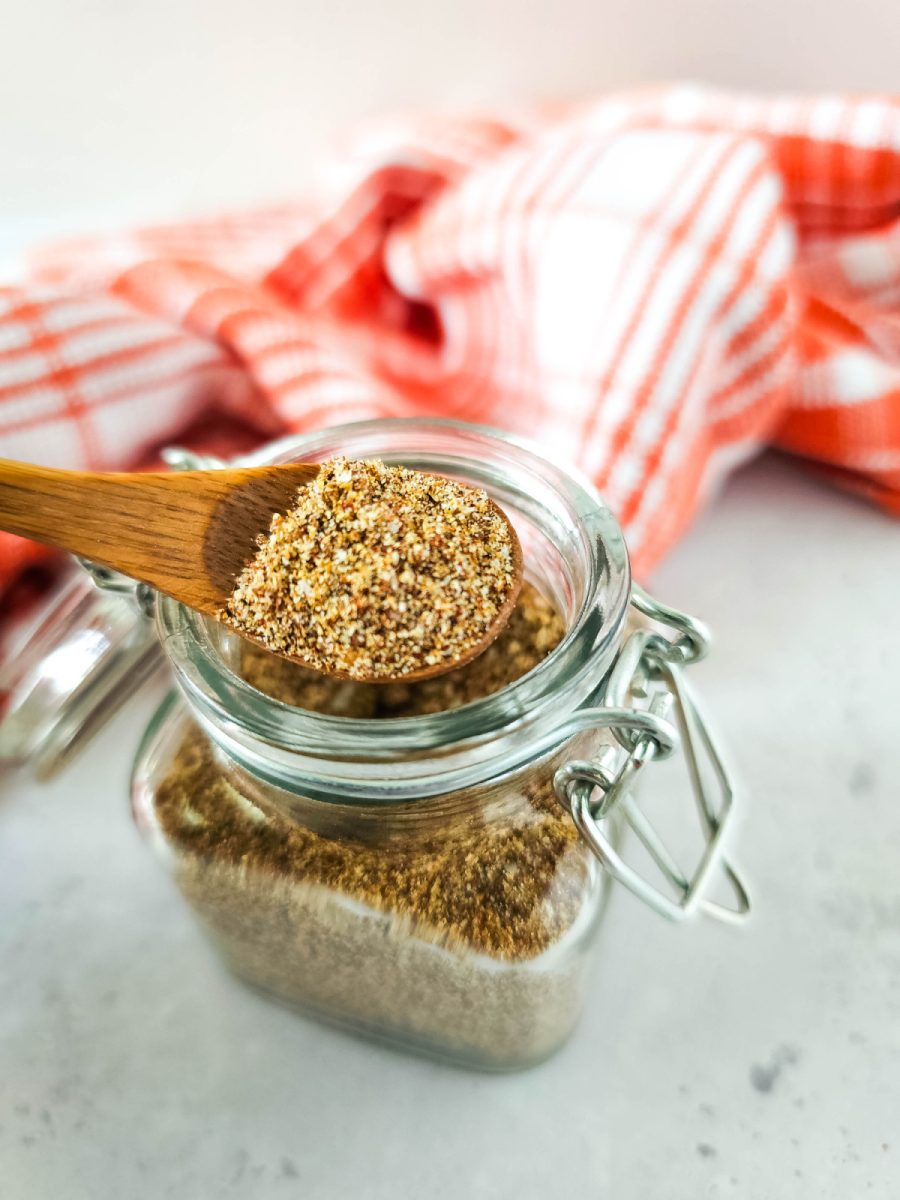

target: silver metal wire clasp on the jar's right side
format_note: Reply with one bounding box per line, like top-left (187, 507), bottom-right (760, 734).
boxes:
top-left (553, 587), bottom-right (750, 922)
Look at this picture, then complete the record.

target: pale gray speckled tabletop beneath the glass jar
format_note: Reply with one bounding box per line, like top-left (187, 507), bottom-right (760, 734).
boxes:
top-left (0, 461), bottom-right (900, 1200)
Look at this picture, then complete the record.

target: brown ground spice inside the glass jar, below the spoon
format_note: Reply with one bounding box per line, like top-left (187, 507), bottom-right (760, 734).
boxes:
top-left (156, 584), bottom-right (609, 1067)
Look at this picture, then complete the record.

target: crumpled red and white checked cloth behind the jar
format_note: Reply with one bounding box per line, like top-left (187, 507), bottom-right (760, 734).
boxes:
top-left (0, 86), bottom-right (900, 600)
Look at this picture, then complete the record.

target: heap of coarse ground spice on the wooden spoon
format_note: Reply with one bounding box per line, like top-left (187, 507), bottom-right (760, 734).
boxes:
top-left (223, 458), bottom-right (518, 679)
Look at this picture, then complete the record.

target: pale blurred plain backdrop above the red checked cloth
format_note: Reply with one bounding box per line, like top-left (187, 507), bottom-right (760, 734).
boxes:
top-left (0, 0), bottom-right (899, 250)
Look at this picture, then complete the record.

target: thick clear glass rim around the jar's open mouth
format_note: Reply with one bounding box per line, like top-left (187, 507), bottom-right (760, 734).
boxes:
top-left (156, 418), bottom-right (631, 794)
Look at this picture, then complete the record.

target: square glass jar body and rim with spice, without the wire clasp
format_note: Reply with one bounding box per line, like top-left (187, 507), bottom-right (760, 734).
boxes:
top-left (132, 421), bottom-right (631, 1069)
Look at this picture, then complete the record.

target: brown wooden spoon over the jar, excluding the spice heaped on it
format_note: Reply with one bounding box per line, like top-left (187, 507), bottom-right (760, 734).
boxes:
top-left (0, 458), bottom-right (522, 683)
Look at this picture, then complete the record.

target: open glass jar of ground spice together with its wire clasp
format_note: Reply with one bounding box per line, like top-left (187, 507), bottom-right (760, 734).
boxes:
top-left (0, 420), bottom-right (749, 1069)
